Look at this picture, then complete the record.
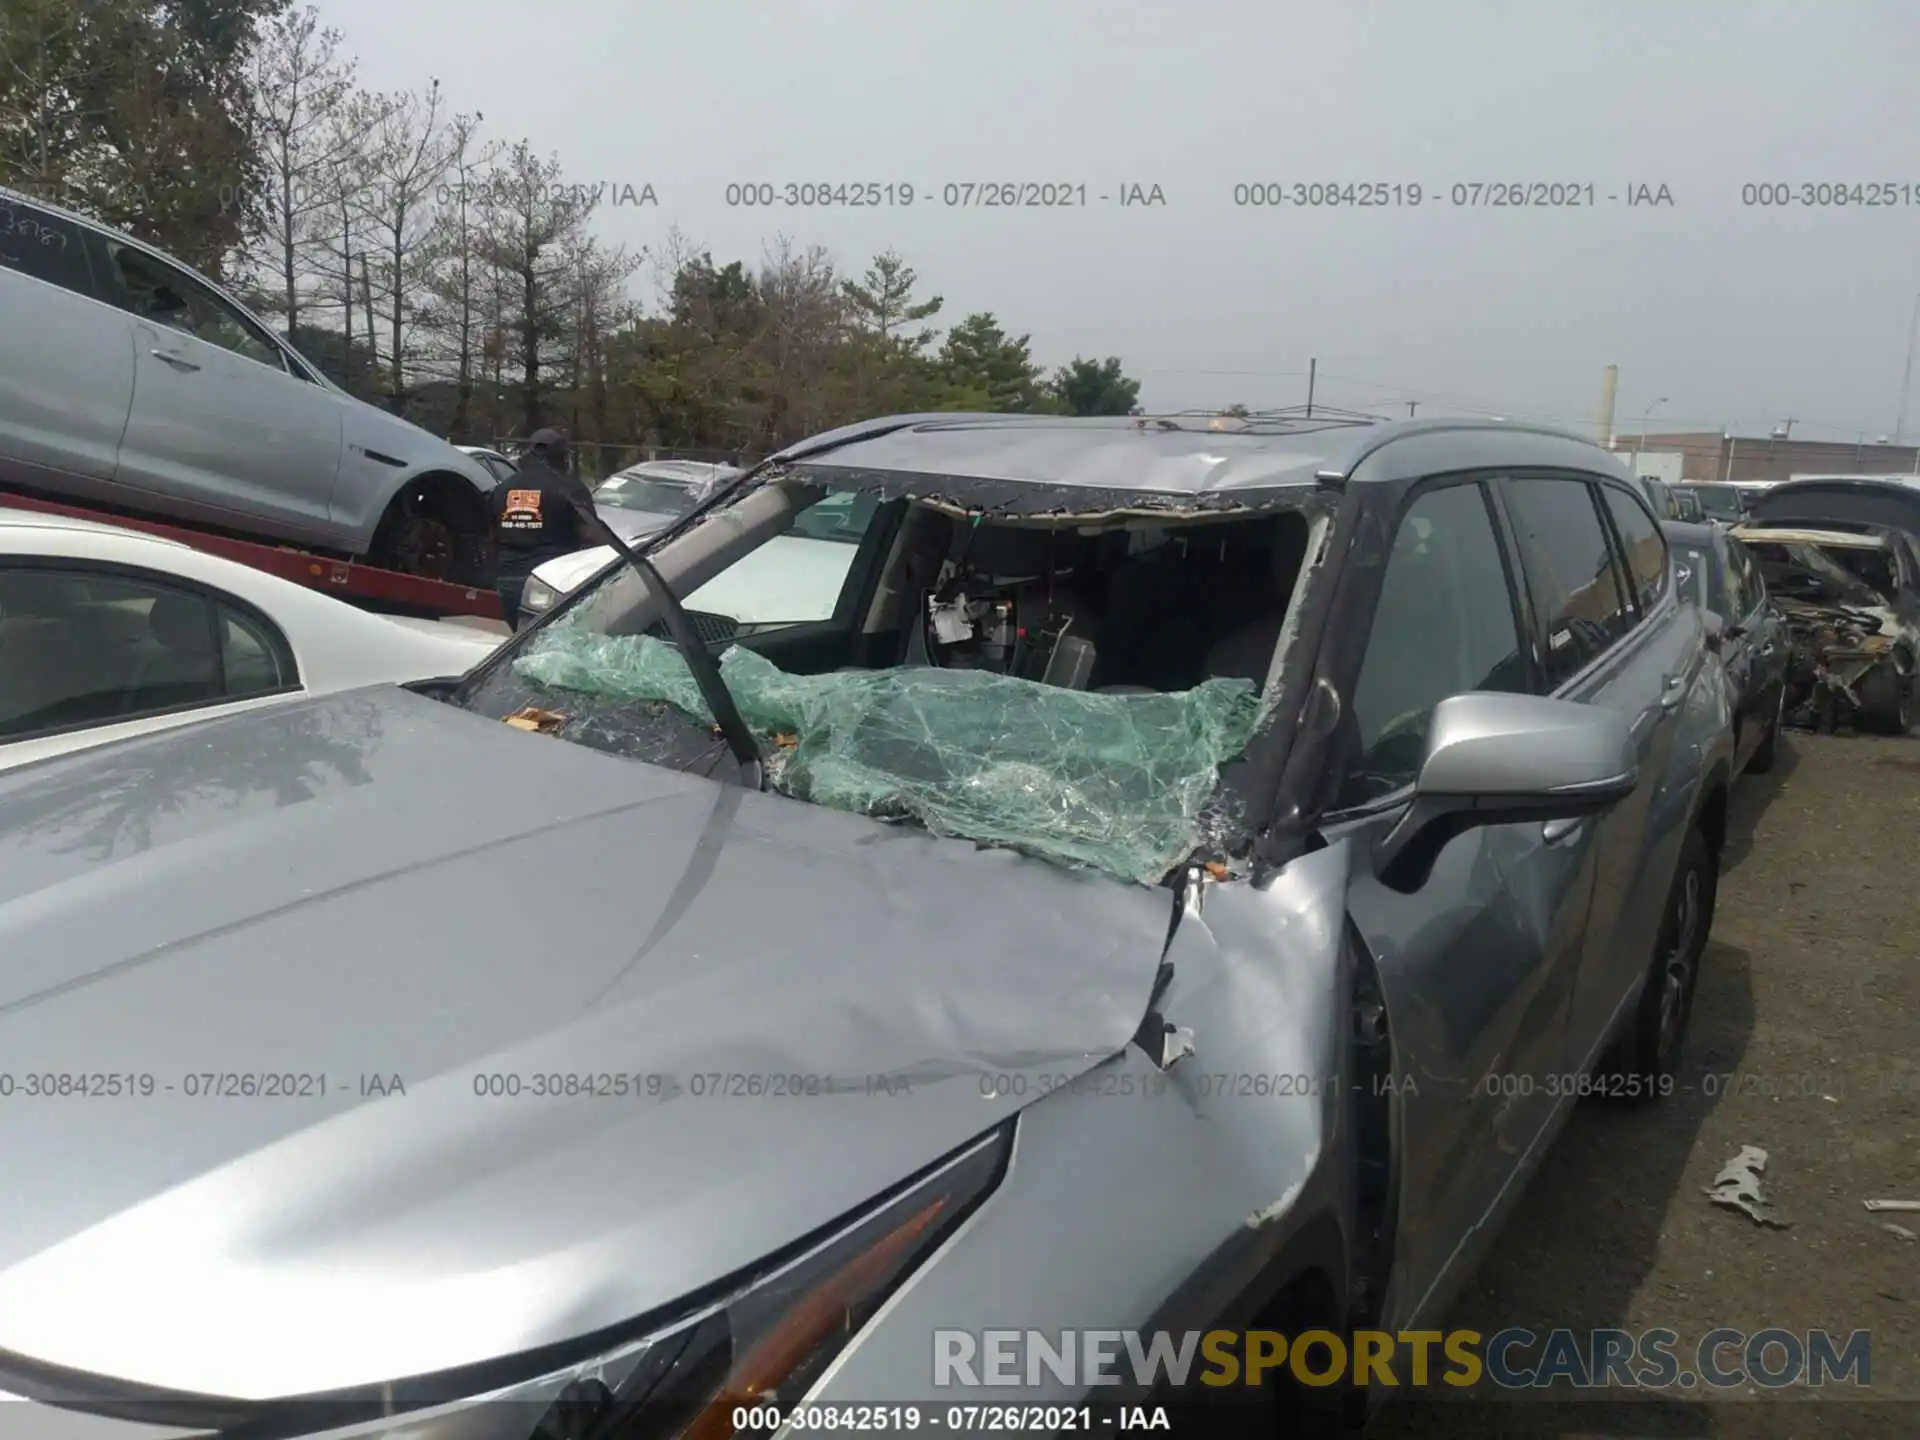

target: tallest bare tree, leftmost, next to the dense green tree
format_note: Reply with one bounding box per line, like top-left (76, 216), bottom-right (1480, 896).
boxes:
top-left (241, 6), bottom-right (360, 336)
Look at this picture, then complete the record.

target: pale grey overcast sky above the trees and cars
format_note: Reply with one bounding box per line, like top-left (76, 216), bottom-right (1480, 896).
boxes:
top-left (319, 0), bottom-right (1920, 440)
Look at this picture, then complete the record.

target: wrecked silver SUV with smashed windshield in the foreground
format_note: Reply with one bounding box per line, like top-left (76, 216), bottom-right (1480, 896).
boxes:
top-left (0, 415), bottom-right (1730, 1440)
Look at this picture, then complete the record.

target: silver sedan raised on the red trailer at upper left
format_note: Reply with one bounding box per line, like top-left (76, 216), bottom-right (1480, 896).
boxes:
top-left (0, 190), bottom-right (493, 582)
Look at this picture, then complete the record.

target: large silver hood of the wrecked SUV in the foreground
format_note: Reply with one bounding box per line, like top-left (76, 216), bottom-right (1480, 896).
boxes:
top-left (0, 687), bottom-right (1169, 1398)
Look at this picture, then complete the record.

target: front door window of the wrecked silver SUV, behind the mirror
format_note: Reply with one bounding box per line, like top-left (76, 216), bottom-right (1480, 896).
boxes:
top-left (1344, 484), bottom-right (1530, 804)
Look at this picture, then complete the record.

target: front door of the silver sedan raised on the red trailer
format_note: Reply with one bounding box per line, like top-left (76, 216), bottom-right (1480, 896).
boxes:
top-left (96, 238), bottom-right (342, 543)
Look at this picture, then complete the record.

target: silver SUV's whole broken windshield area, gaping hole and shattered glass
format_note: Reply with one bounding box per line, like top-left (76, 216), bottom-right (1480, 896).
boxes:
top-left (459, 478), bottom-right (1317, 883)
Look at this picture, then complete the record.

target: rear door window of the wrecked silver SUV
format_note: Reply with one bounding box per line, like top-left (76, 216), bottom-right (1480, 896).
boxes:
top-left (1507, 478), bottom-right (1634, 689)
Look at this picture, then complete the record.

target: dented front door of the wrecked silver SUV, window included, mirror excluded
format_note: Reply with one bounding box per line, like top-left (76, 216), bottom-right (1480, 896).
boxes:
top-left (1323, 476), bottom-right (1594, 1329)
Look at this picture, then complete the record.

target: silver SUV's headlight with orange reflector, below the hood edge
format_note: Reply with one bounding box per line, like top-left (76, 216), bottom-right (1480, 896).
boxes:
top-left (86, 1127), bottom-right (1012, 1440)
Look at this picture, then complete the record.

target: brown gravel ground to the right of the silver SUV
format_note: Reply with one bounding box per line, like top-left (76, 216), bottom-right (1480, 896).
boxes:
top-left (1369, 732), bottom-right (1920, 1440)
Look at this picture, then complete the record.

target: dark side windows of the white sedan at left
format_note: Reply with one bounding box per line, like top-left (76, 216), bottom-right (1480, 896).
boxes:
top-left (0, 566), bottom-right (298, 739)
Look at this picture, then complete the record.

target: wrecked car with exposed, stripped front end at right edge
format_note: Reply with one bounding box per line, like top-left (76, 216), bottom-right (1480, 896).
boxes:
top-left (1734, 524), bottom-right (1920, 735)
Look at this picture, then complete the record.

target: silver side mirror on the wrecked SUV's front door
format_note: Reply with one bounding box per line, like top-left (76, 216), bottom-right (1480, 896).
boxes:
top-left (1373, 691), bottom-right (1640, 893)
